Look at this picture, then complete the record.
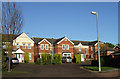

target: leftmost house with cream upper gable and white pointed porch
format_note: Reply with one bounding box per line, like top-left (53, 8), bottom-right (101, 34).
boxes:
top-left (2, 32), bottom-right (34, 63)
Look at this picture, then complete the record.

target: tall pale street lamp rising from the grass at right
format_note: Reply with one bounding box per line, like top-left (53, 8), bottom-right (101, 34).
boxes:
top-left (91, 11), bottom-right (101, 71)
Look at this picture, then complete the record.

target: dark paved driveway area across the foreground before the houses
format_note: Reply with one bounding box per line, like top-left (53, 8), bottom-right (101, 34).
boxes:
top-left (3, 63), bottom-right (118, 77)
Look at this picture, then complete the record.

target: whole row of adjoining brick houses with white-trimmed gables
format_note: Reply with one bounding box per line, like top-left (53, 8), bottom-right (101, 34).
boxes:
top-left (3, 32), bottom-right (102, 63)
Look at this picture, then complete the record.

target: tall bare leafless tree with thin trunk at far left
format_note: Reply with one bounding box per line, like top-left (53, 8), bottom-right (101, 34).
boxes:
top-left (1, 2), bottom-right (23, 72)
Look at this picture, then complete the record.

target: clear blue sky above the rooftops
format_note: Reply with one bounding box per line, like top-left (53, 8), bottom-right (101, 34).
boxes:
top-left (17, 2), bottom-right (118, 44)
